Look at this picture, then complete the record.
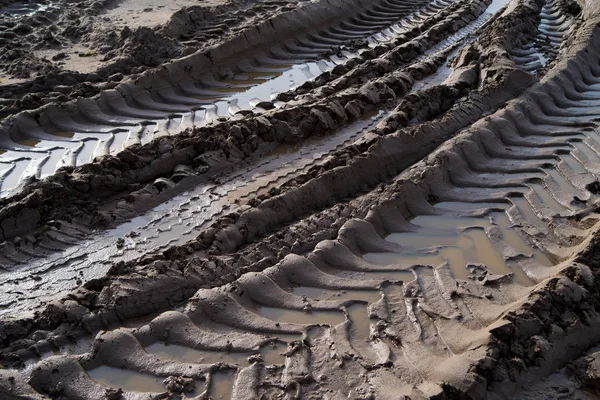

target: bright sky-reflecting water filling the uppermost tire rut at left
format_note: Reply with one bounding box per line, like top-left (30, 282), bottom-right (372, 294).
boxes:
top-left (0, 54), bottom-right (335, 195)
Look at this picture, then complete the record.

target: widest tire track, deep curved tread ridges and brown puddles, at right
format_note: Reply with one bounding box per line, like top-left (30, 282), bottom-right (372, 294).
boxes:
top-left (4, 2), bottom-right (600, 399)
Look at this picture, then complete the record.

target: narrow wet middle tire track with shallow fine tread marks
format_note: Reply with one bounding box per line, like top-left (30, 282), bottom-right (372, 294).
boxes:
top-left (2, 2), bottom-right (489, 311)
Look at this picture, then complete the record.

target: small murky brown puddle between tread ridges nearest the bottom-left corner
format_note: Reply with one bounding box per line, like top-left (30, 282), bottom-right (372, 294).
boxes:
top-left (86, 365), bottom-right (167, 393)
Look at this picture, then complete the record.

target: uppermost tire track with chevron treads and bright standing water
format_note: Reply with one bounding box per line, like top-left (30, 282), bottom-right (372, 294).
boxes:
top-left (0, 1), bottom-right (451, 195)
